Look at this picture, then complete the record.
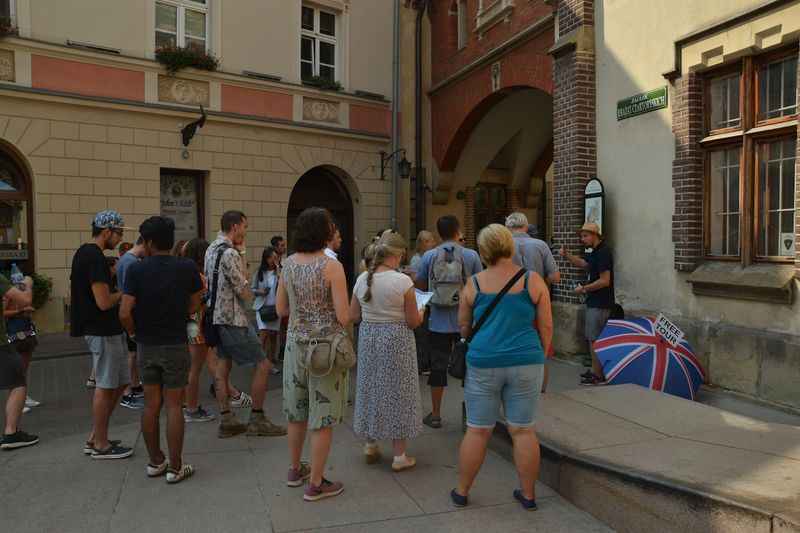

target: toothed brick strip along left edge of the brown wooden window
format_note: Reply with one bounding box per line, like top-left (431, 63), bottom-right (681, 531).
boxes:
top-left (672, 73), bottom-right (703, 272)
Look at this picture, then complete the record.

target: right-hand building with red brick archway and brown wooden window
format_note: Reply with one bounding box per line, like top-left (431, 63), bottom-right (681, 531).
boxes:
top-left (402, 0), bottom-right (800, 407)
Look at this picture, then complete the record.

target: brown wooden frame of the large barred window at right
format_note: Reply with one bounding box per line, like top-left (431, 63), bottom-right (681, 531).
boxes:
top-left (702, 44), bottom-right (800, 267)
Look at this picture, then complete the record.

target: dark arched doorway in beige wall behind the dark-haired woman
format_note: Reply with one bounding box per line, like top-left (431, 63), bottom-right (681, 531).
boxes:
top-left (286, 167), bottom-right (355, 287)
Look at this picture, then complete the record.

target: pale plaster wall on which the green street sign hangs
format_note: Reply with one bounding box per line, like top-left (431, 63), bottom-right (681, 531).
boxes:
top-left (595, 0), bottom-right (800, 334)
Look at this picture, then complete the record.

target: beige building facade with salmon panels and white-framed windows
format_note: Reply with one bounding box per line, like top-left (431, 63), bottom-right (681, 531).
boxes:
top-left (0, 0), bottom-right (392, 330)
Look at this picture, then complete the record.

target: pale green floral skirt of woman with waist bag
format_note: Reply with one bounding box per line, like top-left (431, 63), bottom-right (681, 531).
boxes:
top-left (283, 337), bottom-right (350, 430)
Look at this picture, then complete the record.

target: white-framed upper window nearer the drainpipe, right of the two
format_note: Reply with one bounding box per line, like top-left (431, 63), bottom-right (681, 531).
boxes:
top-left (300, 6), bottom-right (337, 82)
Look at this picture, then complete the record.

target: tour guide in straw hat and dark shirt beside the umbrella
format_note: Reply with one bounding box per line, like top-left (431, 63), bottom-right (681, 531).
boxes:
top-left (561, 222), bottom-right (614, 385)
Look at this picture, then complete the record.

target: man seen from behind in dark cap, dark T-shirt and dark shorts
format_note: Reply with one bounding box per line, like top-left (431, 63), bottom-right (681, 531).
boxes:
top-left (120, 217), bottom-right (203, 483)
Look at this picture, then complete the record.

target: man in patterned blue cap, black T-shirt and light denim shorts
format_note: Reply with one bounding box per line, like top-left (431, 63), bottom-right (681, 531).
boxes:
top-left (70, 211), bottom-right (133, 459)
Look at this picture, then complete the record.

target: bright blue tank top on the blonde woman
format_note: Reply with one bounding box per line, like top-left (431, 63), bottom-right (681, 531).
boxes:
top-left (467, 273), bottom-right (545, 368)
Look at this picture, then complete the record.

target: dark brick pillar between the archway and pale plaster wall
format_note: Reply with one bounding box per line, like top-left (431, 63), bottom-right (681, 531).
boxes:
top-left (552, 0), bottom-right (597, 303)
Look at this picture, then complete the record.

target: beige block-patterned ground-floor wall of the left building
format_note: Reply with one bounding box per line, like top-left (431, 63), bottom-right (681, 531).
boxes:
top-left (0, 96), bottom-right (390, 324)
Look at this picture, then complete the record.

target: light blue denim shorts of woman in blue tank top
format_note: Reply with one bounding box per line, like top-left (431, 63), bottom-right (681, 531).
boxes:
top-left (464, 365), bottom-right (544, 429)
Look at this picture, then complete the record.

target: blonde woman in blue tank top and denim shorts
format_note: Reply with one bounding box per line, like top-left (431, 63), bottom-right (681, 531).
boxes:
top-left (450, 224), bottom-right (553, 510)
